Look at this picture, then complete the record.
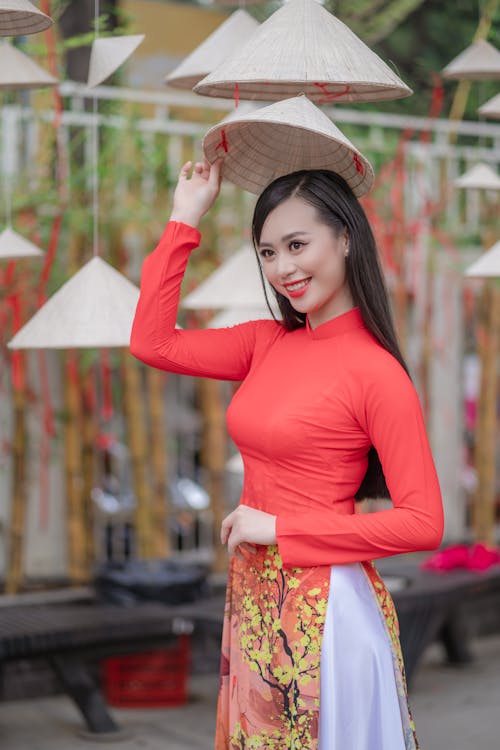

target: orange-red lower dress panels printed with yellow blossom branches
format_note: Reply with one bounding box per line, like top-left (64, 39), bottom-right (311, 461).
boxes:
top-left (215, 545), bottom-right (418, 750)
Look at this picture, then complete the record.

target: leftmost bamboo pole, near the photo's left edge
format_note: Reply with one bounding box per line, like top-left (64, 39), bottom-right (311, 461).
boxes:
top-left (5, 388), bottom-right (27, 594)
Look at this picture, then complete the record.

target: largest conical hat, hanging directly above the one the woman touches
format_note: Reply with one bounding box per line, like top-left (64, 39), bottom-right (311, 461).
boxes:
top-left (194, 0), bottom-right (412, 103)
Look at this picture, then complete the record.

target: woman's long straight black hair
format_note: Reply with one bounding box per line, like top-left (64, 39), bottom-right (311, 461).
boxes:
top-left (252, 169), bottom-right (408, 500)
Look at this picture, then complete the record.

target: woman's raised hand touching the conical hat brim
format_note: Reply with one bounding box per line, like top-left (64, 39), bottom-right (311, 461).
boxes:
top-left (170, 159), bottom-right (222, 227)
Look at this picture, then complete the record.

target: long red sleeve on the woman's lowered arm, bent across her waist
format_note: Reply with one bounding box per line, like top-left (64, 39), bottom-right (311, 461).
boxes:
top-left (277, 357), bottom-right (443, 566)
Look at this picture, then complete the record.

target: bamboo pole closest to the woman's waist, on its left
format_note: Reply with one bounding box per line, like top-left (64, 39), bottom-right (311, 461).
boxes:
top-left (198, 378), bottom-right (227, 573)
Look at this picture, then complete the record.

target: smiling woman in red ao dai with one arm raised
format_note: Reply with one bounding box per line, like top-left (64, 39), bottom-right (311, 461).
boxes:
top-left (131, 162), bottom-right (443, 750)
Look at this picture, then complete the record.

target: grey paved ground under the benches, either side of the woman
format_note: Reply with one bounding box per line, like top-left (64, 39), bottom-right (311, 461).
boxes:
top-left (0, 636), bottom-right (500, 750)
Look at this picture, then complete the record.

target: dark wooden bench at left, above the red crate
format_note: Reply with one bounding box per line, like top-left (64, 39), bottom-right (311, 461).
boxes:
top-left (0, 602), bottom-right (222, 736)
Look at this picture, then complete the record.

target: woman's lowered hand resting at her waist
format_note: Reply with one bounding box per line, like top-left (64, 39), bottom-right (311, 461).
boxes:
top-left (220, 505), bottom-right (276, 555)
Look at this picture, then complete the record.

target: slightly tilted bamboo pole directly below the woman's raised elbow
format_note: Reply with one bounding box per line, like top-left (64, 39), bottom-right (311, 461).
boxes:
top-left (122, 351), bottom-right (155, 560)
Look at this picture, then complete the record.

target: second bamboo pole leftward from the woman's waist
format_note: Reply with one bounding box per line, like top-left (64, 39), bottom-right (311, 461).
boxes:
top-left (146, 367), bottom-right (171, 557)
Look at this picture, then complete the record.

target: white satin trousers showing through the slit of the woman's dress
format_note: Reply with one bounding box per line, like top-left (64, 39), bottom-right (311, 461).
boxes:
top-left (319, 563), bottom-right (405, 750)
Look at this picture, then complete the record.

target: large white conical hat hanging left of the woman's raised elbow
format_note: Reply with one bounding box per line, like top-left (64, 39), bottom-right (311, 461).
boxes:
top-left (9, 257), bottom-right (139, 349)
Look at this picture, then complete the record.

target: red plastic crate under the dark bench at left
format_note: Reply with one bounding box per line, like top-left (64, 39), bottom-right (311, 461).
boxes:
top-left (102, 635), bottom-right (191, 708)
